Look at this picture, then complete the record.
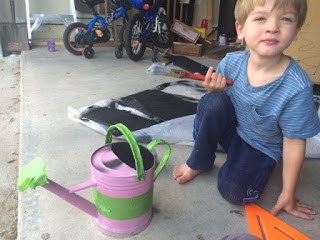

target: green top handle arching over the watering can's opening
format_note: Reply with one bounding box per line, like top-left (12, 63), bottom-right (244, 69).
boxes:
top-left (105, 123), bottom-right (145, 181)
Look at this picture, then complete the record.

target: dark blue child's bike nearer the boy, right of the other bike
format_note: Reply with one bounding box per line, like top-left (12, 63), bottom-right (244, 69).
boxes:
top-left (125, 0), bottom-right (174, 61)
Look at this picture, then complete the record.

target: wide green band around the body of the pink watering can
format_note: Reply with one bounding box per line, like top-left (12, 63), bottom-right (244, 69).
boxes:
top-left (93, 188), bottom-right (153, 220)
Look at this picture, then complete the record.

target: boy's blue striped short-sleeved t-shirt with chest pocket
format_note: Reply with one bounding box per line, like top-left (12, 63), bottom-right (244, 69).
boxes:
top-left (217, 51), bottom-right (320, 161)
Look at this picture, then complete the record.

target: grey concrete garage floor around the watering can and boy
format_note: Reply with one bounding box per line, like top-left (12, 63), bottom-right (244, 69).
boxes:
top-left (18, 47), bottom-right (320, 240)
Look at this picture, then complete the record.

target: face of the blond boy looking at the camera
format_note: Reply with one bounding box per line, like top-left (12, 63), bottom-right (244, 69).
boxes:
top-left (236, 0), bottom-right (300, 57)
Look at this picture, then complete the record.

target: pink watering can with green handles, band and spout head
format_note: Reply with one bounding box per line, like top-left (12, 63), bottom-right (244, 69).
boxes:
top-left (18, 123), bottom-right (171, 237)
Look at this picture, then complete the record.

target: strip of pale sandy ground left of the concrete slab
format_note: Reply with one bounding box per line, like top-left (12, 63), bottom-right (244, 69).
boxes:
top-left (0, 56), bottom-right (21, 240)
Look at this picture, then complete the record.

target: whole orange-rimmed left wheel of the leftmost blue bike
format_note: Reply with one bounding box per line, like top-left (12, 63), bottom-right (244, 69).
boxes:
top-left (63, 22), bottom-right (88, 55)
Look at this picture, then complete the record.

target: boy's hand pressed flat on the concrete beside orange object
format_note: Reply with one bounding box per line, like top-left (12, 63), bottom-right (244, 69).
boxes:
top-left (271, 192), bottom-right (316, 220)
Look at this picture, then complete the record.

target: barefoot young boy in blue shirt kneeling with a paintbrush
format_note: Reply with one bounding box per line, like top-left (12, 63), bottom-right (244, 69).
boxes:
top-left (173, 0), bottom-right (320, 220)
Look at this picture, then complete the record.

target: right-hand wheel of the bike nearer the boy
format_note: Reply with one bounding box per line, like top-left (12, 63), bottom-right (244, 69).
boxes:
top-left (151, 13), bottom-right (174, 48)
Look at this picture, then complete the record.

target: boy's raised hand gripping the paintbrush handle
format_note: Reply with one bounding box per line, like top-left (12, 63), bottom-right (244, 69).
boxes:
top-left (203, 67), bottom-right (227, 92)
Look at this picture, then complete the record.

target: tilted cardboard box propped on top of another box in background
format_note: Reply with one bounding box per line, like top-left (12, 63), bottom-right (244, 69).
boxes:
top-left (171, 19), bottom-right (200, 43)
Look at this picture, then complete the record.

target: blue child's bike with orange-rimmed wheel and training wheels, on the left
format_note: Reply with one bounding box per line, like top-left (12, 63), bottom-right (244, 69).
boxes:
top-left (63, 0), bottom-right (132, 59)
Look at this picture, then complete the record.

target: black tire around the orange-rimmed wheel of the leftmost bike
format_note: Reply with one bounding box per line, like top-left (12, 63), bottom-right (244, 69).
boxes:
top-left (63, 22), bottom-right (88, 55)
